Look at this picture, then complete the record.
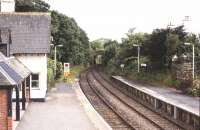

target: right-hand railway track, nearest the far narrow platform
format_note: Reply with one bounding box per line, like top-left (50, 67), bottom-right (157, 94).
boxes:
top-left (79, 70), bottom-right (181, 130)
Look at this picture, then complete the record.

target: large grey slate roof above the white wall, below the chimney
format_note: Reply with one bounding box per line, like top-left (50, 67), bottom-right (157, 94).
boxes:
top-left (0, 12), bottom-right (51, 54)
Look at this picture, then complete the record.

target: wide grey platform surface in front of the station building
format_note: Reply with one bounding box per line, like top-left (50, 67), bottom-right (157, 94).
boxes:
top-left (16, 83), bottom-right (96, 130)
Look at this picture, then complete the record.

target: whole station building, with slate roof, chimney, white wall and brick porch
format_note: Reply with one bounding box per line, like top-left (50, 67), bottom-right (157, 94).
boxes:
top-left (0, 0), bottom-right (51, 130)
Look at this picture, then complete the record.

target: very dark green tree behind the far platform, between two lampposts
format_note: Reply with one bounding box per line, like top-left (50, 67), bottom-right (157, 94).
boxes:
top-left (144, 26), bottom-right (186, 70)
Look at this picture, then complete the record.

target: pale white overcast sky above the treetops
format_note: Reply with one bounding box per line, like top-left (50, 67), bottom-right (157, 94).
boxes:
top-left (49, 0), bottom-right (200, 40)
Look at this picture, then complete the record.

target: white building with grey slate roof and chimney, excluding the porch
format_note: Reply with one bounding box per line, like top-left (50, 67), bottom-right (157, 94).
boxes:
top-left (0, 0), bottom-right (51, 101)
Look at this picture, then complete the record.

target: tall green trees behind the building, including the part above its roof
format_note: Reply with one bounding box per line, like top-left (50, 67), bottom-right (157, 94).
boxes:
top-left (16, 0), bottom-right (90, 65)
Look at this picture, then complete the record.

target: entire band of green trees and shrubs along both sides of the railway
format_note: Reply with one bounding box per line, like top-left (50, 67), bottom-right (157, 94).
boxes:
top-left (16, 0), bottom-right (200, 96)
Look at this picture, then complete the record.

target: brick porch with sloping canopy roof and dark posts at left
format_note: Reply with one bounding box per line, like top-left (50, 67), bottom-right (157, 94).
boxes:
top-left (0, 52), bottom-right (31, 130)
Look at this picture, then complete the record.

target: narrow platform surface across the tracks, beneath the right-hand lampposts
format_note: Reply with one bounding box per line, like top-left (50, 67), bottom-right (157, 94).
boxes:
top-left (113, 76), bottom-right (200, 116)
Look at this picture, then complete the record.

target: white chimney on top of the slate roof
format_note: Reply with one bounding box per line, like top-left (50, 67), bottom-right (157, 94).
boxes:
top-left (0, 0), bottom-right (15, 12)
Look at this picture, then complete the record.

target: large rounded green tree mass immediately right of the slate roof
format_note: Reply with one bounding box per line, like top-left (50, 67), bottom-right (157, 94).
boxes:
top-left (51, 11), bottom-right (90, 65)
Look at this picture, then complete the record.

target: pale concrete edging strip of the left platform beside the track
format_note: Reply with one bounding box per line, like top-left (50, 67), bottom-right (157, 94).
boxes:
top-left (73, 82), bottom-right (112, 130)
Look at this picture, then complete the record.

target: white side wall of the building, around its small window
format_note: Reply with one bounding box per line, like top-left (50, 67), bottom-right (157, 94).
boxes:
top-left (16, 54), bottom-right (47, 99)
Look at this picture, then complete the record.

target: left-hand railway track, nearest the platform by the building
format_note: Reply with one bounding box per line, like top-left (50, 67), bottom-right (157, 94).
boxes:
top-left (80, 72), bottom-right (133, 130)
